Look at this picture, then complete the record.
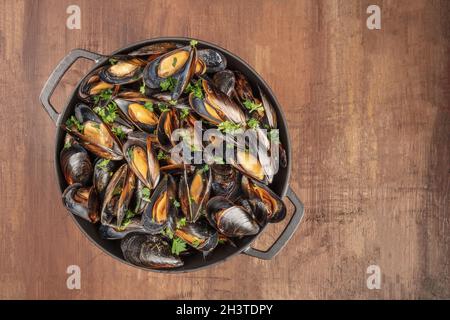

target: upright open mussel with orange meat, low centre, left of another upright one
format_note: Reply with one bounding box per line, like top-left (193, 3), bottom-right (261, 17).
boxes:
top-left (142, 175), bottom-right (177, 234)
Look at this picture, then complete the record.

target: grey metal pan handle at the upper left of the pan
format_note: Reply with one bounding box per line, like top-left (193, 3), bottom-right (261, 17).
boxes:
top-left (39, 49), bottom-right (103, 124)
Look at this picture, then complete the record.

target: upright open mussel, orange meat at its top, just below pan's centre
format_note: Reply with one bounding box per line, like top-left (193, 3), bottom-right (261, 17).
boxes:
top-left (178, 169), bottom-right (212, 222)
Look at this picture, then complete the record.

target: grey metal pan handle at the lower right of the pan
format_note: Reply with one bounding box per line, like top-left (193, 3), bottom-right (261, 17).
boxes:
top-left (243, 187), bottom-right (304, 260)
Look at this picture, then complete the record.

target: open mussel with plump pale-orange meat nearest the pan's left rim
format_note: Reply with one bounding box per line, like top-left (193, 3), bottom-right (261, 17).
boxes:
top-left (62, 103), bottom-right (123, 160)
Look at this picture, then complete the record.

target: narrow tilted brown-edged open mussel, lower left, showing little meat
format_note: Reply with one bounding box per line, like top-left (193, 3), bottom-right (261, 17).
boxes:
top-left (101, 164), bottom-right (136, 228)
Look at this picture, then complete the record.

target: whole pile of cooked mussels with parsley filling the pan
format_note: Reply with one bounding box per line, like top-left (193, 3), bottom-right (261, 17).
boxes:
top-left (60, 40), bottom-right (286, 269)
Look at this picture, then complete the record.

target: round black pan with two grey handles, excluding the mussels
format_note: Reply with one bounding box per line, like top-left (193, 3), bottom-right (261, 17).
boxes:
top-left (40, 38), bottom-right (303, 273)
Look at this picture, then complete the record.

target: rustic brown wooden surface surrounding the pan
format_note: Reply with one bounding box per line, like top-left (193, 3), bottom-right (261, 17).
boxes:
top-left (0, 0), bottom-right (450, 299)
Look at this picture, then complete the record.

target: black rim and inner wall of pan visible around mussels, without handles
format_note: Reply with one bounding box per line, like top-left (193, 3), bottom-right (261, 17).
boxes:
top-left (55, 38), bottom-right (291, 272)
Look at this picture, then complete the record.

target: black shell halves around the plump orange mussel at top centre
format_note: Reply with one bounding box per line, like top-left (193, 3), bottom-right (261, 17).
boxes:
top-left (144, 46), bottom-right (197, 100)
